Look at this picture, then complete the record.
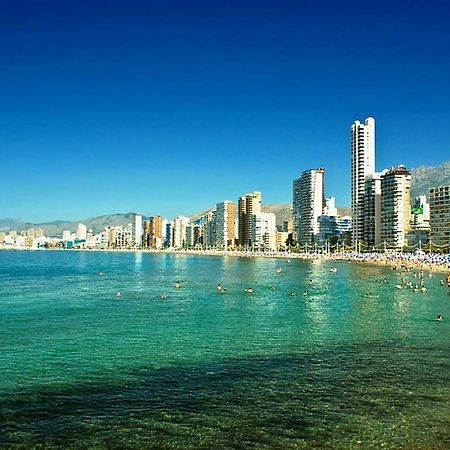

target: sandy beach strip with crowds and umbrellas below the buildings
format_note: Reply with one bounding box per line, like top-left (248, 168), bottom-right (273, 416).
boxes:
top-left (0, 248), bottom-right (450, 273)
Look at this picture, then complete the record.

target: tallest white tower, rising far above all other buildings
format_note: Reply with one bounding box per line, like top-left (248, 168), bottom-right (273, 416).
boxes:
top-left (350, 117), bottom-right (375, 245)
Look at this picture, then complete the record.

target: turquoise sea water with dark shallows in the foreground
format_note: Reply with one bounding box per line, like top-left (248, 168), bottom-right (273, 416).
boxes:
top-left (0, 251), bottom-right (450, 449)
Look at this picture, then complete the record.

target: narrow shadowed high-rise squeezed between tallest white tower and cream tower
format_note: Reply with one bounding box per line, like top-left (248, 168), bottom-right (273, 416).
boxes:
top-left (360, 170), bottom-right (387, 248)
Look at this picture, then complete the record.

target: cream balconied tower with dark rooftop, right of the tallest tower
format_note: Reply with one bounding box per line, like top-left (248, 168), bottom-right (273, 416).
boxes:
top-left (381, 166), bottom-right (411, 248)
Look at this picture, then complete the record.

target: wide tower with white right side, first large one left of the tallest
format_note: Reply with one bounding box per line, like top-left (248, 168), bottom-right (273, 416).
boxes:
top-left (292, 167), bottom-right (325, 245)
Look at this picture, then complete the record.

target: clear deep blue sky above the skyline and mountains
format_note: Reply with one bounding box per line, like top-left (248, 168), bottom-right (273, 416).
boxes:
top-left (0, 0), bottom-right (450, 222)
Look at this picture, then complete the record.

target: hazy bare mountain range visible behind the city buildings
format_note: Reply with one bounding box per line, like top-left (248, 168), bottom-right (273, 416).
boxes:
top-left (0, 161), bottom-right (450, 236)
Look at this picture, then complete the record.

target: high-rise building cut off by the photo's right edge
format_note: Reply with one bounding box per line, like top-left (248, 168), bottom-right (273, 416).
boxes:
top-left (429, 186), bottom-right (450, 251)
